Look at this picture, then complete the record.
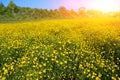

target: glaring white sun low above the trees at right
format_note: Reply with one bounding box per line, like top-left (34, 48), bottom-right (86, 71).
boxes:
top-left (92, 0), bottom-right (119, 12)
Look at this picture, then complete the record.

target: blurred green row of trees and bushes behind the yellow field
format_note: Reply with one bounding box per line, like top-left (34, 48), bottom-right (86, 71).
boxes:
top-left (0, 1), bottom-right (120, 20)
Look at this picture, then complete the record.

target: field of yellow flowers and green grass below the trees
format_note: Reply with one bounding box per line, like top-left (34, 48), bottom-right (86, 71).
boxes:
top-left (0, 18), bottom-right (120, 80)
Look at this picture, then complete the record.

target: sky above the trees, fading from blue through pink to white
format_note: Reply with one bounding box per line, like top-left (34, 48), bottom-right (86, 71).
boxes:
top-left (0, 0), bottom-right (120, 11)
